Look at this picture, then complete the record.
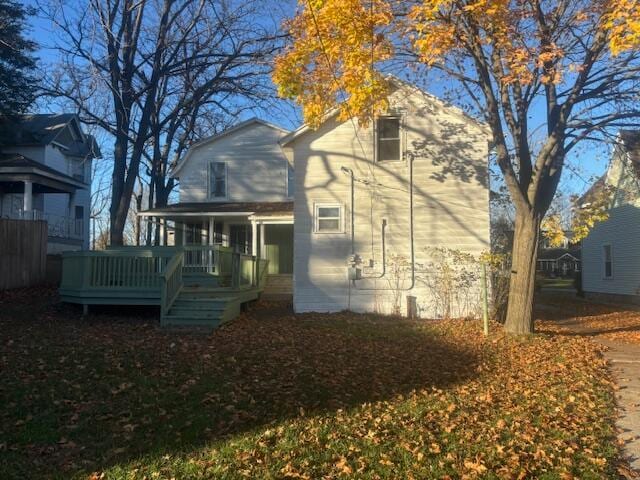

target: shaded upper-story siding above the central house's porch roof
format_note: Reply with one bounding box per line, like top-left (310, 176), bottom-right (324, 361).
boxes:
top-left (179, 122), bottom-right (290, 202)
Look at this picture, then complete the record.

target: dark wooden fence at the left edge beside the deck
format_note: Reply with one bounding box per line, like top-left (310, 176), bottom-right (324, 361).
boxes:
top-left (0, 218), bottom-right (47, 290)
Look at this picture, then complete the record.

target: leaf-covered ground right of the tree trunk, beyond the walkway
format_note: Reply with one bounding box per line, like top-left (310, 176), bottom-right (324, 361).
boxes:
top-left (537, 295), bottom-right (640, 344)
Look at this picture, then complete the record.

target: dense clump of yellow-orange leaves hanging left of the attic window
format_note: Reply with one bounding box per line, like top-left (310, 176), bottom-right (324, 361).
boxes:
top-left (273, 0), bottom-right (393, 126)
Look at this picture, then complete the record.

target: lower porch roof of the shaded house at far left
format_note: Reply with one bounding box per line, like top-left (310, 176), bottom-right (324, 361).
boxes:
top-left (0, 153), bottom-right (87, 193)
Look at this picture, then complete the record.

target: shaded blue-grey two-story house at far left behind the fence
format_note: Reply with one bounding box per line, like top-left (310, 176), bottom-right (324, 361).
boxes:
top-left (0, 114), bottom-right (100, 253)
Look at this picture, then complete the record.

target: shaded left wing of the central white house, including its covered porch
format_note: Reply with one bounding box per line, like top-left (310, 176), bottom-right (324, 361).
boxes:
top-left (142, 119), bottom-right (295, 295)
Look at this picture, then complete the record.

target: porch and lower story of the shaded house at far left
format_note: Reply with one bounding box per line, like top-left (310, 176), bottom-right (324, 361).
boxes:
top-left (0, 153), bottom-right (89, 248)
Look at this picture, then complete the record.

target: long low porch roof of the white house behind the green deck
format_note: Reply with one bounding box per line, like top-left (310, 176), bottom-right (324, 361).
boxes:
top-left (138, 202), bottom-right (293, 217)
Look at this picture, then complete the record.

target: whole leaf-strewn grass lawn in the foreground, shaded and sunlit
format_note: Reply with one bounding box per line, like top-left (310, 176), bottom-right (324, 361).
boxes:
top-left (0, 291), bottom-right (618, 479)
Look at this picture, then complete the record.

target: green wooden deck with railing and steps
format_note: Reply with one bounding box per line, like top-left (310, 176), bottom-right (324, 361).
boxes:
top-left (60, 246), bottom-right (268, 327)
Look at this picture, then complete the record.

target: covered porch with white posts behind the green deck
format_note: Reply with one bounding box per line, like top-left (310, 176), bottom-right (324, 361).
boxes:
top-left (140, 202), bottom-right (293, 299)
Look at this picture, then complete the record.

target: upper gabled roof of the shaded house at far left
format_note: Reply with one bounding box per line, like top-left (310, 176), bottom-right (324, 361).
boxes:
top-left (0, 113), bottom-right (101, 158)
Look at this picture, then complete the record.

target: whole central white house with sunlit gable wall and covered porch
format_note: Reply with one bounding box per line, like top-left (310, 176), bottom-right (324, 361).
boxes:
top-left (142, 80), bottom-right (490, 317)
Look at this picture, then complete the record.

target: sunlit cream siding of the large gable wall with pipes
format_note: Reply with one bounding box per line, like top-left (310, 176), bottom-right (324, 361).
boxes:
top-left (287, 88), bottom-right (489, 317)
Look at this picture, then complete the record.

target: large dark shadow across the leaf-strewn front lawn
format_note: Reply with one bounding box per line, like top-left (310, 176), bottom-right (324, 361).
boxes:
top-left (0, 296), bottom-right (478, 476)
